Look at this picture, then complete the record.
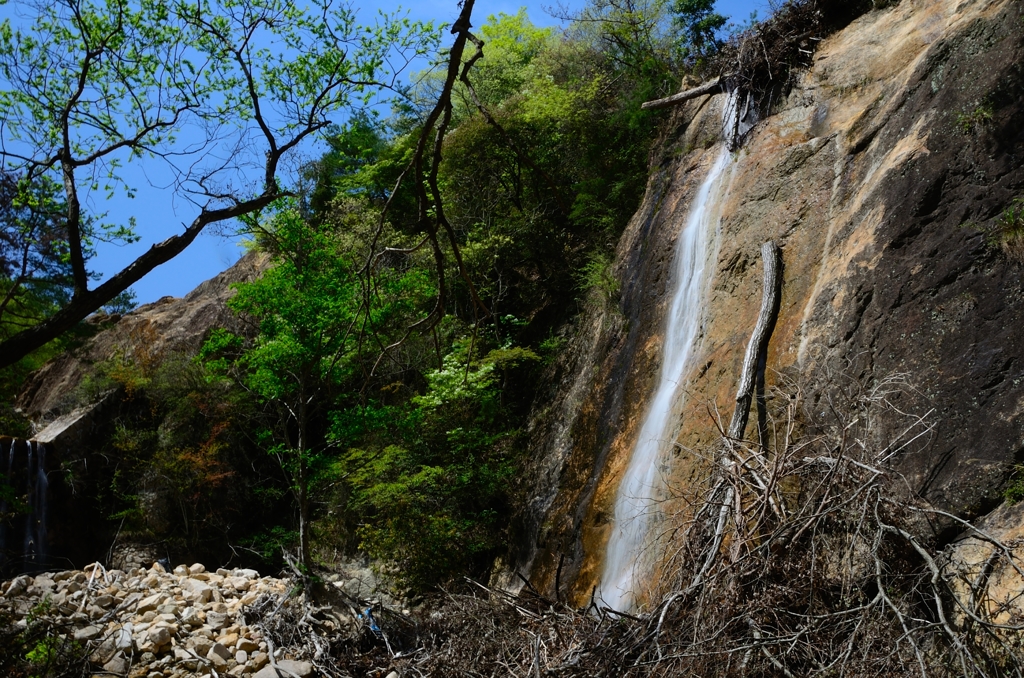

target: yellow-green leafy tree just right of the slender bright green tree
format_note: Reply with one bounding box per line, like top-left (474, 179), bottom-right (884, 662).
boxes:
top-left (335, 338), bottom-right (540, 590)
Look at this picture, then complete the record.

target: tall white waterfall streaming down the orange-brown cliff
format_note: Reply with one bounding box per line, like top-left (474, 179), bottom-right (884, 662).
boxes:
top-left (599, 87), bottom-right (750, 610)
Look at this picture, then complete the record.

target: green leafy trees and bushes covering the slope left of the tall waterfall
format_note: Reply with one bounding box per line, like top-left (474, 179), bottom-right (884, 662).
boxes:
top-left (0, 1), bottom-right (737, 588)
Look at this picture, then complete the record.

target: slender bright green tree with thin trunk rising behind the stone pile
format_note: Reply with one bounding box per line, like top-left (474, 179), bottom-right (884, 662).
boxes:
top-left (205, 206), bottom-right (358, 566)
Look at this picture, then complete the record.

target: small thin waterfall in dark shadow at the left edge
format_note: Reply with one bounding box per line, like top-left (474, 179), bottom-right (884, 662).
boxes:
top-left (0, 439), bottom-right (50, 571)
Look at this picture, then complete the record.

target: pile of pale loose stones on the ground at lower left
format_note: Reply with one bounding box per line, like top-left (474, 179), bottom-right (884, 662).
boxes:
top-left (0, 563), bottom-right (313, 678)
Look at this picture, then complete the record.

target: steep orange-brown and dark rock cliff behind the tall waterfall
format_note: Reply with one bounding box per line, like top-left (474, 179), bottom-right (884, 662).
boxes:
top-left (520, 0), bottom-right (1024, 602)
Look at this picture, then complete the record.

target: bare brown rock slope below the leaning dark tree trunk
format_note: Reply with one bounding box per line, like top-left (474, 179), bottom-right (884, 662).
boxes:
top-left (17, 253), bottom-right (266, 426)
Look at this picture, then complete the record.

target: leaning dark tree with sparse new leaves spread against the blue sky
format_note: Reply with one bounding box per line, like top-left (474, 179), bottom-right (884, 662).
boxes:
top-left (0, 0), bottom-right (436, 367)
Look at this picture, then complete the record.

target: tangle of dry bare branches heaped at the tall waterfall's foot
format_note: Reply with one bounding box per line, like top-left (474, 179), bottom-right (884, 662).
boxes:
top-left (245, 358), bottom-right (1024, 678)
